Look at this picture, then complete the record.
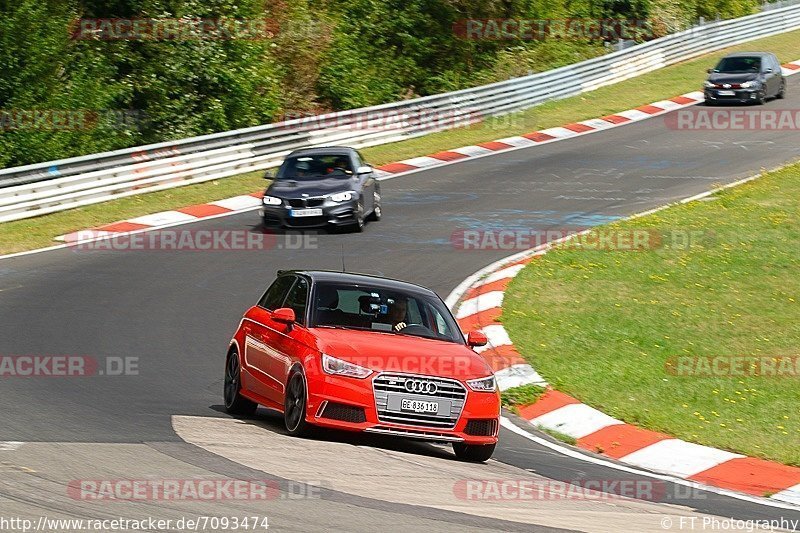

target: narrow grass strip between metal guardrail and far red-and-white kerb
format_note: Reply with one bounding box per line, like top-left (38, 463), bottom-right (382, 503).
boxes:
top-left (0, 31), bottom-right (800, 254)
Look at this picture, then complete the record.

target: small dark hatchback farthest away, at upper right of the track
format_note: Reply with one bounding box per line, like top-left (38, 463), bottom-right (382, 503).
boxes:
top-left (703, 52), bottom-right (786, 105)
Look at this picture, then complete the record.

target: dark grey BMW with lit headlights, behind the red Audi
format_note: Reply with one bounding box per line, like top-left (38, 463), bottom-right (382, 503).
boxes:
top-left (261, 147), bottom-right (381, 231)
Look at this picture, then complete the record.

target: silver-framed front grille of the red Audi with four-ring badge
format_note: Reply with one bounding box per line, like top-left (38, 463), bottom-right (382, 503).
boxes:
top-left (372, 374), bottom-right (467, 429)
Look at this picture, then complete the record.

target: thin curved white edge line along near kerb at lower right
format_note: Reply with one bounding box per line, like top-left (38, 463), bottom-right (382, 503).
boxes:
top-left (500, 416), bottom-right (797, 511)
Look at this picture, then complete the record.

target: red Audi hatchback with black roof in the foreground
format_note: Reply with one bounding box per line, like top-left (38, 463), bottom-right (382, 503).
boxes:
top-left (225, 271), bottom-right (500, 462)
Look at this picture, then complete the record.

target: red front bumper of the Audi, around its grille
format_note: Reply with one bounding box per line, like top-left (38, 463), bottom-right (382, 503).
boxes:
top-left (306, 374), bottom-right (500, 444)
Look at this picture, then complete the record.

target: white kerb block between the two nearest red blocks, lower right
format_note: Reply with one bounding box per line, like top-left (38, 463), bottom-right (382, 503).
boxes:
top-left (620, 439), bottom-right (744, 477)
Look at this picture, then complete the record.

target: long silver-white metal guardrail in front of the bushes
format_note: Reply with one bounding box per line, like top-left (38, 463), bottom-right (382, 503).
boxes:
top-left (0, 5), bottom-right (800, 222)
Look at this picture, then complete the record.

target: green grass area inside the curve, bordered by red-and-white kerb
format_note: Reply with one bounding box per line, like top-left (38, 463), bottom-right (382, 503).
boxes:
top-left (502, 165), bottom-right (800, 466)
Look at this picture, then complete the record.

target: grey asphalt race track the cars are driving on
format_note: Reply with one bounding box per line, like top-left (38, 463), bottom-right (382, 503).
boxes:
top-left (0, 78), bottom-right (800, 531)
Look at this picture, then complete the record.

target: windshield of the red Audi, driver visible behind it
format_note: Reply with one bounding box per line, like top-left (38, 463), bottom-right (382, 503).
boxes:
top-left (311, 282), bottom-right (464, 344)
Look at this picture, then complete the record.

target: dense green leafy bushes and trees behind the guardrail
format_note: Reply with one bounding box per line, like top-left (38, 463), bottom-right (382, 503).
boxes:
top-left (0, 0), bottom-right (757, 167)
